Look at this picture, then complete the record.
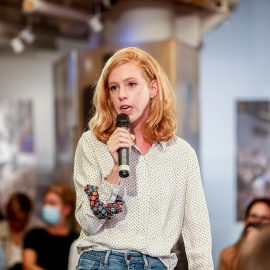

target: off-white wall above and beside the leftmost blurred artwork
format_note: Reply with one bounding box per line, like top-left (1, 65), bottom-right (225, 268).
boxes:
top-left (0, 51), bottom-right (59, 169)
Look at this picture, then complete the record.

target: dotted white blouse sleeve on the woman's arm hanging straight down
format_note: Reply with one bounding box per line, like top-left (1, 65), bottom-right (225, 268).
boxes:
top-left (180, 149), bottom-right (214, 270)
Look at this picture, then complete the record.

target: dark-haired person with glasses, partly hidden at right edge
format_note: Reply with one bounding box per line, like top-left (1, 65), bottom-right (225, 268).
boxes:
top-left (218, 198), bottom-right (270, 270)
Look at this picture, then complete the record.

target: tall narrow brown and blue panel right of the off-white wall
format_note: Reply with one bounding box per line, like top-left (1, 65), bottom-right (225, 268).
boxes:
top-left (53, 53), bottom-right (76, 185)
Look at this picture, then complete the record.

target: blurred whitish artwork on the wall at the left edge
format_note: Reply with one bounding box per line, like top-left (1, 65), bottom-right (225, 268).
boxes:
top-left (0, 98), bottom-right (37, 212)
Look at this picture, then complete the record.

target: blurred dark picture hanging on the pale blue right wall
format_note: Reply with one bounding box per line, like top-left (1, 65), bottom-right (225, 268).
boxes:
top-left (236, 100), bottom-right (270, 220)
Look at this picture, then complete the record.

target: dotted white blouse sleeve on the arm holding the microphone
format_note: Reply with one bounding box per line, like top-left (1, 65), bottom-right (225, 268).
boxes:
top-left (74, 131), bottom-right (120, 234)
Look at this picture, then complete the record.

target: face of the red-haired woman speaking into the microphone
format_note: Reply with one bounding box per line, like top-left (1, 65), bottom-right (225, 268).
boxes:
top-left (108, 62), bottom-right (158, 129)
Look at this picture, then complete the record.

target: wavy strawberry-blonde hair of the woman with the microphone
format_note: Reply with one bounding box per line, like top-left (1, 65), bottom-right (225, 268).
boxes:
top-left (89, 47), bottom-right (177, 143)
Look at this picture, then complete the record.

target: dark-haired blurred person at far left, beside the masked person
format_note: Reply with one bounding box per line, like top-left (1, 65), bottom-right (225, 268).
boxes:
top-left (0, 193), bottom-right (32, 270)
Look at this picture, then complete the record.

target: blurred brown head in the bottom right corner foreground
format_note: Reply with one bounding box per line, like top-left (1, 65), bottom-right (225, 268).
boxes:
top-left (237, 224), bottom-right (270, 270)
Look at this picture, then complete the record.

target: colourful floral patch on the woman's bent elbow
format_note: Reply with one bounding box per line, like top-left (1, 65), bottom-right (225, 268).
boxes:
top-left (84, 185), bottom-right (125, 219)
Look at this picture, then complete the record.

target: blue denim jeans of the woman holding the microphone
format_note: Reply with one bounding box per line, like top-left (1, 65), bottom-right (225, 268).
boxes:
top-left (76, 250), bottom-right (167, 270)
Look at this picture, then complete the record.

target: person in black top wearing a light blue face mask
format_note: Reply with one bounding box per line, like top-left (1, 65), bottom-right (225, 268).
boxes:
top-left (23, 184), bottom-right (78, 270)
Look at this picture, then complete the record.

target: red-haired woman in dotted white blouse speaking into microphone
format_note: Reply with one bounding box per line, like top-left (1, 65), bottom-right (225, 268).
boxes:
top-left (74, 47), bottom-right (213, 270)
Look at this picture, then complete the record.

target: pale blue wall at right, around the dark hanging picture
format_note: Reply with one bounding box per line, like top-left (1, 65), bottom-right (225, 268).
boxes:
top-left (200, 0), bottom-right (270, 266)
